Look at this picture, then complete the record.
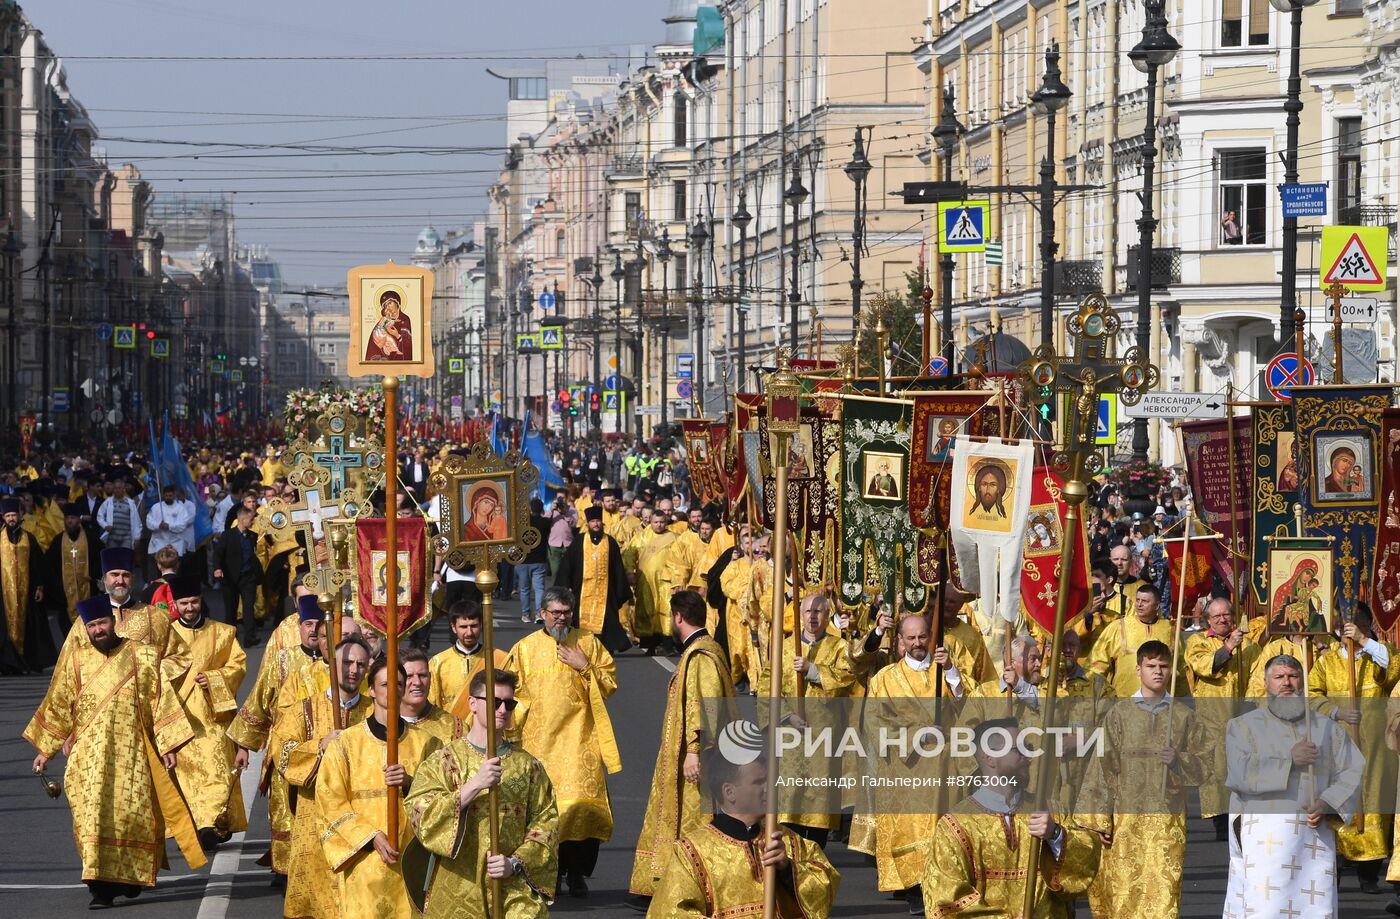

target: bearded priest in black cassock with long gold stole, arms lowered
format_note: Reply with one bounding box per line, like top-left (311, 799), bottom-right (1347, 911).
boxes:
top-left (554, 504), bottom-right (631, 654)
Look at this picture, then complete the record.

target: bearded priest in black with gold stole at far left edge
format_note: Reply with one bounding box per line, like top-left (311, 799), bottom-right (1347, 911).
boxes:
top-left (0, 497), bottom-right (55, 675)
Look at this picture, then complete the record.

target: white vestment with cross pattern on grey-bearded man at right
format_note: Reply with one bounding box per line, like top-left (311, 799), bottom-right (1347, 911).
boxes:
top-left (1224, 707), bottom-right (1364, 919)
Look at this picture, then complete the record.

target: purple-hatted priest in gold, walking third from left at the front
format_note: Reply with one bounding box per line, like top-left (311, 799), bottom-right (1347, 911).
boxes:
top-left (228, 593), bottom-right (325, 876)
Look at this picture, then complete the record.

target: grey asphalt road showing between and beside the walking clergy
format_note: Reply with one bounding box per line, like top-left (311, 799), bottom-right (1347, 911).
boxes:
top-left (0, 601), bottom-right (1389, 919)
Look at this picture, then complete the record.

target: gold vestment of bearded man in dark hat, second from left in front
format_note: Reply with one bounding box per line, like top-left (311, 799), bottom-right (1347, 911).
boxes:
top-left (174, 615), bottom-right (248, 834)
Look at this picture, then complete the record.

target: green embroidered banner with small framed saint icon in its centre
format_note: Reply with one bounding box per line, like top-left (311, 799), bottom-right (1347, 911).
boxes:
top-left (840, 395), bottom-right (928, 612)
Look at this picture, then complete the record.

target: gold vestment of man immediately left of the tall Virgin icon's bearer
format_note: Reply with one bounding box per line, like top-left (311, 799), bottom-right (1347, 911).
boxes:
top-left (267, 664), bottom-right (374, 919)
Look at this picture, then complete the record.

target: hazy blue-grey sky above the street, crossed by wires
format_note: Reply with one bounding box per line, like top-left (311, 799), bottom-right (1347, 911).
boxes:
top-left (32, 0), bottom-right (669, 284)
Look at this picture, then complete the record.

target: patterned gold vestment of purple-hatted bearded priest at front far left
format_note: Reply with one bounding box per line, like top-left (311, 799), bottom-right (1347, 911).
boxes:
top-left (23, 641), bottom-right (197, 887)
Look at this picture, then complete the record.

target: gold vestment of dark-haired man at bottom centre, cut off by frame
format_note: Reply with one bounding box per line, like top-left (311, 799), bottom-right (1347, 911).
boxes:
top-left (647, 814), bottom-right (841, 919)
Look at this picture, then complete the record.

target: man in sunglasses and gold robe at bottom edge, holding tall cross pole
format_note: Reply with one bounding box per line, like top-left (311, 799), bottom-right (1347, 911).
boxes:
top-left (923, 717), bottom-right (1097, 919)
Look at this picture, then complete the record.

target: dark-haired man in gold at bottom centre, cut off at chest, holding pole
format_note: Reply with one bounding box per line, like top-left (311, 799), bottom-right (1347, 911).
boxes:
top-left (647, 754), bottom-right (841, 919)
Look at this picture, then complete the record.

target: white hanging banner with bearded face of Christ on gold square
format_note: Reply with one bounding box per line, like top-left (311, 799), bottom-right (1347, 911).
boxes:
top-left (948, 437), bottom-right (1035, 622)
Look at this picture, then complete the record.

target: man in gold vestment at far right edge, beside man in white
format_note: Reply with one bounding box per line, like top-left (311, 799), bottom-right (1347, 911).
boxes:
top-left (1308, 604), bottom-right (1400, 894)
